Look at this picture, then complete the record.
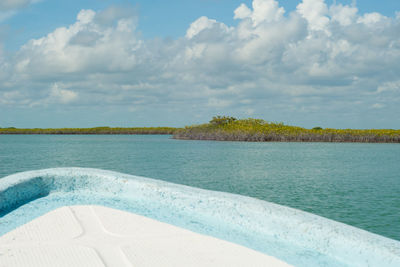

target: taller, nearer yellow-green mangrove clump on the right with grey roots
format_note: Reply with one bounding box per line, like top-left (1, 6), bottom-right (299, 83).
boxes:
top-left (173, 116), bottom-right (400, 143)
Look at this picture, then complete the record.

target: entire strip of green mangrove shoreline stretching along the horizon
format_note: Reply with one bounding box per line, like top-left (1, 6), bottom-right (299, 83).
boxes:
top-left (0, 116), bottom-right (400, 143)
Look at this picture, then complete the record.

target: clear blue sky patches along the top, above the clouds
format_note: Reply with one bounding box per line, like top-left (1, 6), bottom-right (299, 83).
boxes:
top-left (3, 0), bottom-right (400, 50)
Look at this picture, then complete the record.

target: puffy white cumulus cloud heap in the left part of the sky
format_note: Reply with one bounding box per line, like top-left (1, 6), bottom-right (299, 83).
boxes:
top-left (15, 10), bottom-right (141, 77)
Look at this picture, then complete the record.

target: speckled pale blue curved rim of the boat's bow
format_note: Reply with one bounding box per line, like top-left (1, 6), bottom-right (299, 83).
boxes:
top-left (0, 168), bottom-right (400, 266)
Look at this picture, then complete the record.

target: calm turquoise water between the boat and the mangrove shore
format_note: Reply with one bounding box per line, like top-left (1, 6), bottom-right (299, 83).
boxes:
top-left (0, 135), bottom-right (400, 240)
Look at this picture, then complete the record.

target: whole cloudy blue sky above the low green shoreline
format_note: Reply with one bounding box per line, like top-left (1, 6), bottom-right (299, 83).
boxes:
top-left (0, 0), bottom-right (400, 129)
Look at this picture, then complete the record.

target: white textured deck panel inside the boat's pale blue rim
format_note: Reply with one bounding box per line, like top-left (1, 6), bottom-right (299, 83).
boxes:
top-left (0, 206), bottom-right (289, 267)
